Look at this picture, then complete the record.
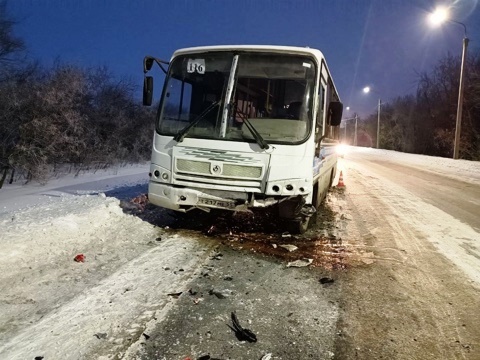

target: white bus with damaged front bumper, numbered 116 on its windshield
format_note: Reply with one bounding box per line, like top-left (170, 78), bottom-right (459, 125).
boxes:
top-left (143, 45), bottom-right (343, 233)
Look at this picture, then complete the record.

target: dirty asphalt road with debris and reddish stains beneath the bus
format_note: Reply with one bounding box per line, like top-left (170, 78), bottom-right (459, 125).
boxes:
top-left (119, 151), bottom-right (480, 360)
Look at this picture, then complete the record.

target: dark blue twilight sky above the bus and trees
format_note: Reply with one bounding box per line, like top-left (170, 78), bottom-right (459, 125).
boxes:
top-left (7, 0), bottom-right (480, 117)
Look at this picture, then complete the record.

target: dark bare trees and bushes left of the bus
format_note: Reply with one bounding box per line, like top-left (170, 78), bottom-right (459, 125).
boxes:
top-left (0, 1), bottom-right (153, 188)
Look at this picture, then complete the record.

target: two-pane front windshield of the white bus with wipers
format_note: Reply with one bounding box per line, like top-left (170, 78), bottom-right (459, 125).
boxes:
top-left (157, 51), bottom-right (316, 144)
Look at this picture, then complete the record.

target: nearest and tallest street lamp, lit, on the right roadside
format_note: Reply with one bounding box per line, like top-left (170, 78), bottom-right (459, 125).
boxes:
top-left (428, 7), bottom-right (469, 159)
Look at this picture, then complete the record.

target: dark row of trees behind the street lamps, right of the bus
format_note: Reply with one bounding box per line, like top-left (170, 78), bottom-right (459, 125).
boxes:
top-left (347, 51), bottom-right (480, 161)
